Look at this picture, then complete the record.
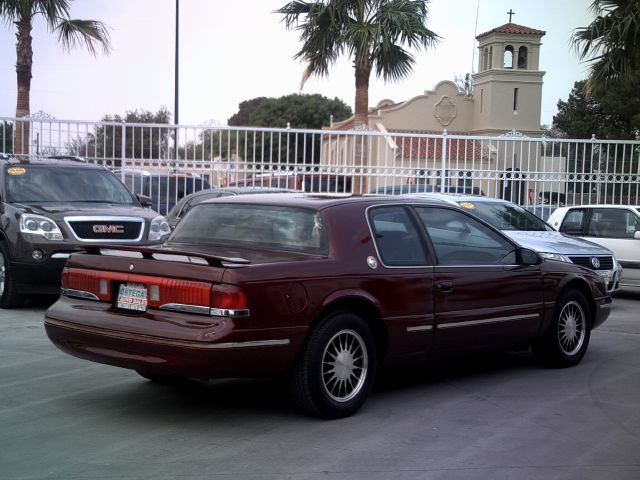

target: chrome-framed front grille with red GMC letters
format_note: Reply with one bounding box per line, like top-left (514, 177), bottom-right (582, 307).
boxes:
top-left (65, 217), bottom-right (144, 243)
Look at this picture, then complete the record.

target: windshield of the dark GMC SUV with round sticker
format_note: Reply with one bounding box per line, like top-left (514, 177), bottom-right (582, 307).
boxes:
top-left (5, 165), bottom-right (137, 205)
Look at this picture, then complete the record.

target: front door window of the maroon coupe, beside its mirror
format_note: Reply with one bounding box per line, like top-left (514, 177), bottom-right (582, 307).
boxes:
top-left (416, 207), bottom-right (517, 265)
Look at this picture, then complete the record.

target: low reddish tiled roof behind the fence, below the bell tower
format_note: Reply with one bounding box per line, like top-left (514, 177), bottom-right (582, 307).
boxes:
top-left (389, 130), bottom-right (486, 162)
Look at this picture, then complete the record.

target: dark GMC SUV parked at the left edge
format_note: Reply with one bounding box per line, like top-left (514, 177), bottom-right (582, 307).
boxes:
top-left (0, 159), bottom-right (170, 308)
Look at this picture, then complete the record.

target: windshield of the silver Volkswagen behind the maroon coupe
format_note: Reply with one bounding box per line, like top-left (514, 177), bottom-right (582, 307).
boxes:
top-left (458, 201), bottom-right (553, 232)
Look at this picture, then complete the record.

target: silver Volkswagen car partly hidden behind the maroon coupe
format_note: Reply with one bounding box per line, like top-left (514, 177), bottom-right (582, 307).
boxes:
top-left (404, 194), bottom-right (623, 292)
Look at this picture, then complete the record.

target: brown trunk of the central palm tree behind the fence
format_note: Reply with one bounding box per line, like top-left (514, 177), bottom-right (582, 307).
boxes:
top-left (352, 65), bottom-right (371, 194)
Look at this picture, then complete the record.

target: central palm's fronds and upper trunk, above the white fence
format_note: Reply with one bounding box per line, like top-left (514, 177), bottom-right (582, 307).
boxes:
top-left (276, 0), bottom-right (439, 127)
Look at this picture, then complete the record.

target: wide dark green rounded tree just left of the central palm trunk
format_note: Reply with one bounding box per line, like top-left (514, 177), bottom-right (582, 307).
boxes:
top-left (186, 94), bottom-right (352, 164)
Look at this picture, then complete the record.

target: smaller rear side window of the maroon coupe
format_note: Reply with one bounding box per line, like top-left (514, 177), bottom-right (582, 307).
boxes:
top-left (369, 206), bottom-right (427, 267)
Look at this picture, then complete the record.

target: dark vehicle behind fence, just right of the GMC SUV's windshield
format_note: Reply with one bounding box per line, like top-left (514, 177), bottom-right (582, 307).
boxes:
top-left (115, 170), bottom-right (211, 215)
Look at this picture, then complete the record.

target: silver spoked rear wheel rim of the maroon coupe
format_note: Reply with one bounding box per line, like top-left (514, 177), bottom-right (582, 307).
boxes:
top-left (322, 330), bottom-right (369, 402)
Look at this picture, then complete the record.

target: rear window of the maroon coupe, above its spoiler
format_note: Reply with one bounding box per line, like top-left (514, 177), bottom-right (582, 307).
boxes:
top-left (169, 203), bottom-right (327, 254)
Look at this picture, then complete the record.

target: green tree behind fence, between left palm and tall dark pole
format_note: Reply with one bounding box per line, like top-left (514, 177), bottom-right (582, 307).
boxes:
top-left (69, 107), bottom-right (173, 166)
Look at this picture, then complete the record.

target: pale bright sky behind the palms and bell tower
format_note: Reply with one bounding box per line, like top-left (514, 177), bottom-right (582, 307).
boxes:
top-left (0, 0), bottom-right (592, 124)
